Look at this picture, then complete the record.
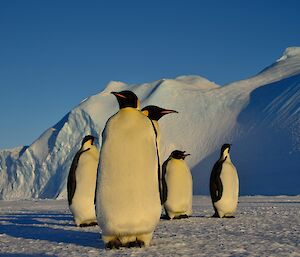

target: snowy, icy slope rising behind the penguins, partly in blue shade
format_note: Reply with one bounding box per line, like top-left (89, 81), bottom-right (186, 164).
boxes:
top-left (0, 47), bottom-right (300, 199)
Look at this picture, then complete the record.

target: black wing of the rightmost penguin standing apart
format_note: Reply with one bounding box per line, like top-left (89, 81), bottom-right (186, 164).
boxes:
top-left (209, 160), bottom-right (225, 202)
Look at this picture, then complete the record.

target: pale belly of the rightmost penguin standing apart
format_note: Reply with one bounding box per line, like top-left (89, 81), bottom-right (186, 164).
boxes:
top-left (214, 161), bottom-right (239, 217)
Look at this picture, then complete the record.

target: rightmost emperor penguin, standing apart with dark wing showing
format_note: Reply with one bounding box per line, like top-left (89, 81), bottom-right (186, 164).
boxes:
top-left (210, 144), bottom-right (239, 218)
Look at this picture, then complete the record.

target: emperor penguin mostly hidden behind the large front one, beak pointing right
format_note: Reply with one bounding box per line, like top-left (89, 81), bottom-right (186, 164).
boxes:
top-left (142, 105), bottom-right (178, 204)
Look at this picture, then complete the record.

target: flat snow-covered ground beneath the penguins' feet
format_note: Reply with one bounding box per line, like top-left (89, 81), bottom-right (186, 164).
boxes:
top-left (0, 196), bottom-right (300, 257)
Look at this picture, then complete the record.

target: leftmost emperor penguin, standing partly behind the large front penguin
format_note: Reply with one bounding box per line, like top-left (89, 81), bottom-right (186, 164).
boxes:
top-left (67, 135), bottom-right (99, 227)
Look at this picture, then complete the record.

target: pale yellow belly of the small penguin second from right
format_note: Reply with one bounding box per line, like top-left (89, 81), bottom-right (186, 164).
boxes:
top-left (165, 159), bottom-right (193, 218)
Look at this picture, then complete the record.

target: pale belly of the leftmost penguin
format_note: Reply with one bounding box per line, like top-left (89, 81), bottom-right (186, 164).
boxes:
top-left (70, 146), bottom-right (99, 225)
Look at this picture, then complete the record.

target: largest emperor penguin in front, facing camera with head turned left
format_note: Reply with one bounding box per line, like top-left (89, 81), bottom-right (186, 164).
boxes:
top-left (96, 90), bottom-right (161, 249)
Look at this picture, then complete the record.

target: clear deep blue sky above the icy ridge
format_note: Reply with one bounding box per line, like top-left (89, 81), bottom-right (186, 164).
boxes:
top-left (0, 0), bottom-right (300, 149)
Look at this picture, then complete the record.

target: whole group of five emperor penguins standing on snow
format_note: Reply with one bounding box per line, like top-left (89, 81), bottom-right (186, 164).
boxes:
top-left (67, 90), bottom-right (238, 249)
